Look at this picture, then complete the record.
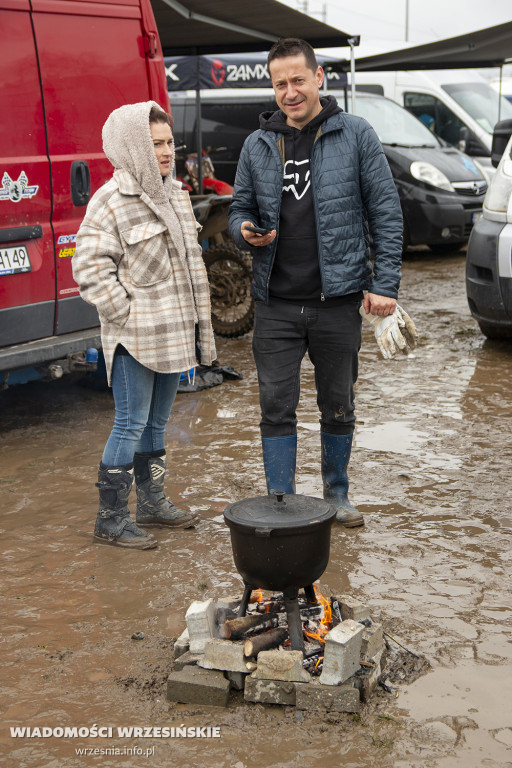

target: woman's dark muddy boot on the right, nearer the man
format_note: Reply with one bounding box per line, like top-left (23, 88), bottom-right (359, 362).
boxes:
top-left (133, 451), bottom-right (199, 528)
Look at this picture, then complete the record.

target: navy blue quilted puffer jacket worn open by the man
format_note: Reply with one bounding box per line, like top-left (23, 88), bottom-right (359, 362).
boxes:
top-left (229, 112), bottom-right (403, 301)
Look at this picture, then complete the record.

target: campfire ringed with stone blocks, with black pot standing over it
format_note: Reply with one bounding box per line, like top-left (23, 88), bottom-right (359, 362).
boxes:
top-left (167, 492), bottom-right (385, 712)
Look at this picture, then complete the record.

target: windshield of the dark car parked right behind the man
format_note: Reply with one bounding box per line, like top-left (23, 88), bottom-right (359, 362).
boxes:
top-left (338, 95), bottom-right (440, 147)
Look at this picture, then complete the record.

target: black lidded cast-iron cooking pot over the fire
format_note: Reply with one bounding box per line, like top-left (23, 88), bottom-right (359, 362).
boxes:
top-left (224, 494), bottom-right (336, 592)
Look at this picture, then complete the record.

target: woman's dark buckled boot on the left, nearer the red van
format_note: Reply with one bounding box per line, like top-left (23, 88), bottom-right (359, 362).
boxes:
top-left (94, 464), bottom-right (158, 549)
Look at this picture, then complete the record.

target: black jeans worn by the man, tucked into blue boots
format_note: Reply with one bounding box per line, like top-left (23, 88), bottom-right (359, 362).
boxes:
top-left (253, 296), bottom-right (361, 437)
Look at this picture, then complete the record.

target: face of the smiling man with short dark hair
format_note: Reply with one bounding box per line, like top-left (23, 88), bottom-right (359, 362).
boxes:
top-left (269, 53), bottom-right (324, 130)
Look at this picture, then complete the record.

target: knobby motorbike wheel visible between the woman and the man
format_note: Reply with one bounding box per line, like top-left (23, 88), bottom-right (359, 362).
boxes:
top-left (203, 243), bottom-right (254, 338)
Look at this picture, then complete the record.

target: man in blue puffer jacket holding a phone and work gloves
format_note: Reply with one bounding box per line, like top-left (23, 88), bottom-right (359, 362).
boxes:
top-left (229, 38), bottom-right (402, 528)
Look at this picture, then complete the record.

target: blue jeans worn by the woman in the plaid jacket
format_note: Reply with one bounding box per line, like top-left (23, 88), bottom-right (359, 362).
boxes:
top-left (102, 354), bottom-right (180, 467)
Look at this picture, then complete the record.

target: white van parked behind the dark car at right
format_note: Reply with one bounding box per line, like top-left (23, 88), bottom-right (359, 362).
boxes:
top-left (355, 69), bottom-right (512, 175)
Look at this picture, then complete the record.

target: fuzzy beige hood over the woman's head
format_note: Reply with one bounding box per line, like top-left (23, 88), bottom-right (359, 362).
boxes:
top-left (101, 101), bottom-right (174, 203)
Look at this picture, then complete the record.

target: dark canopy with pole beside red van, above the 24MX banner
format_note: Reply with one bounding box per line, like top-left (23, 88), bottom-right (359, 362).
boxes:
top-left (151, 0), bottom-right (359, 190)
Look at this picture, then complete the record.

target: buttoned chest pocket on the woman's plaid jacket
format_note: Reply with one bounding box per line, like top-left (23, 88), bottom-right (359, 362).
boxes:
top-left (121, 221), bottom-right (171, 286)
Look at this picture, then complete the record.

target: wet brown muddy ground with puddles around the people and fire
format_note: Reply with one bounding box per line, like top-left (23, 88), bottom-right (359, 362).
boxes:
top-left (0, 252), bottom-right (512, 768)
